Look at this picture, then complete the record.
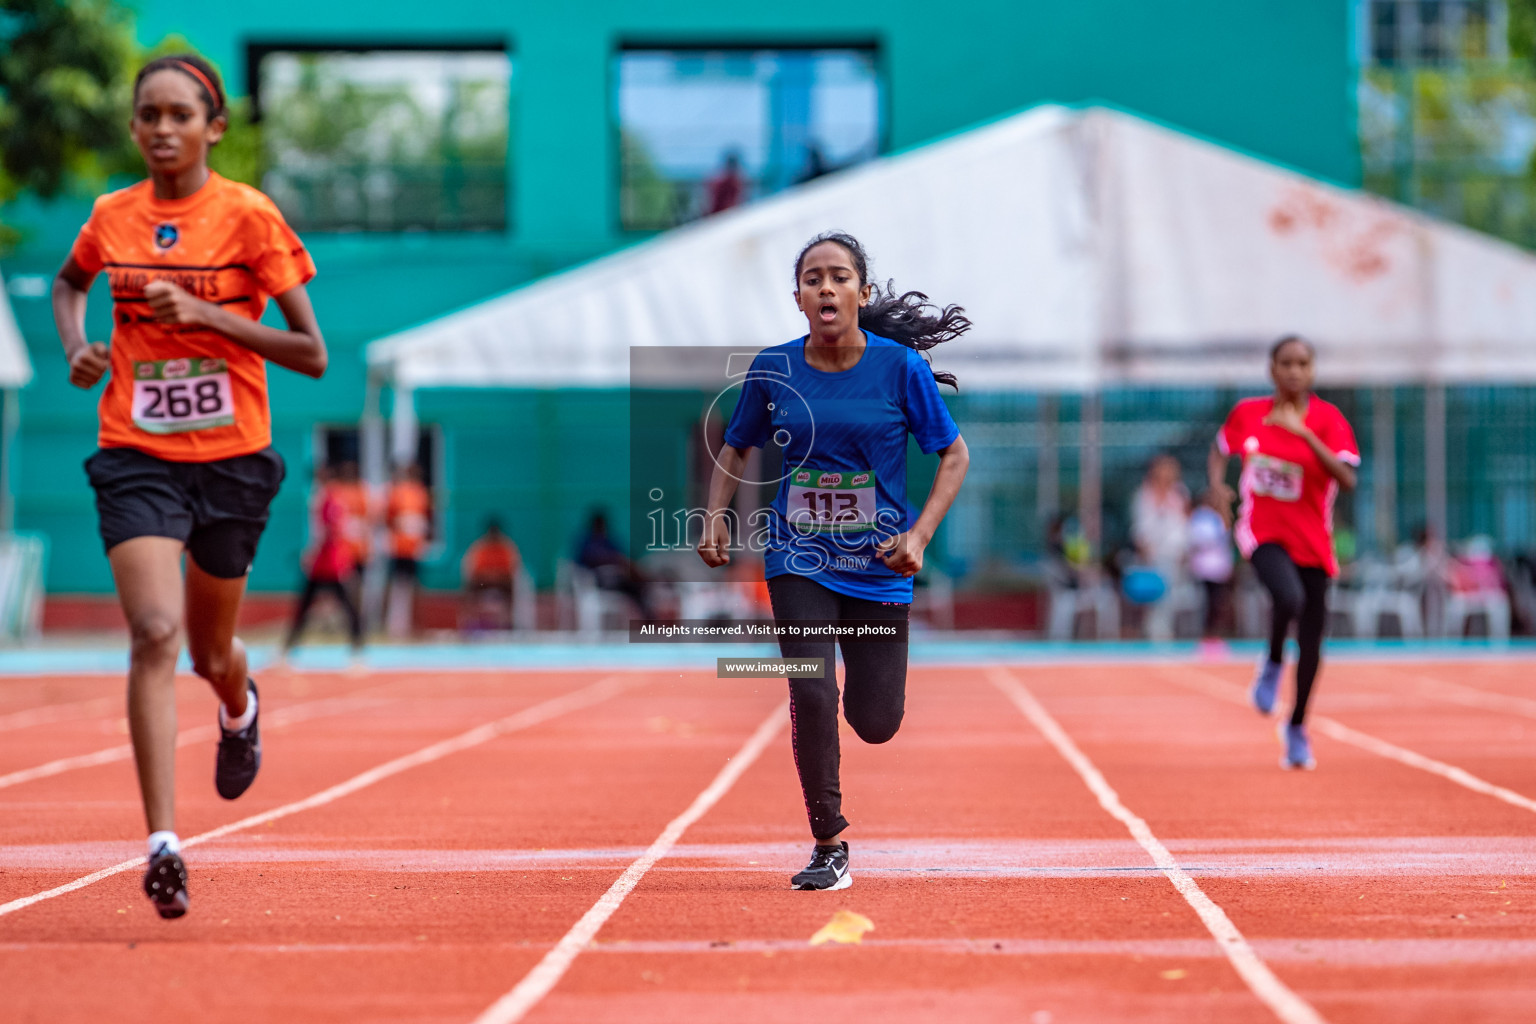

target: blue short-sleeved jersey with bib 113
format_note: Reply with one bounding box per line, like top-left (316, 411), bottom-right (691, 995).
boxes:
top-left (725, 332), bottom-right (960, 603)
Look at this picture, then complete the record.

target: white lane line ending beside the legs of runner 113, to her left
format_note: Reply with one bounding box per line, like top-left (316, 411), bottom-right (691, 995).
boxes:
top-left (475, 705), bottom-right (790, 1024)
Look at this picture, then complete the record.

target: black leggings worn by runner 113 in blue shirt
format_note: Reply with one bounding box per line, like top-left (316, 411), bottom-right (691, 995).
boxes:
top-left (768, 576), bottom-right (911, 840)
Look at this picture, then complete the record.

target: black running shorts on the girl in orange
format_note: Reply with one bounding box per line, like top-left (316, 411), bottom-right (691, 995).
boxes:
top-left (86, 448), bottom-right (286, 579)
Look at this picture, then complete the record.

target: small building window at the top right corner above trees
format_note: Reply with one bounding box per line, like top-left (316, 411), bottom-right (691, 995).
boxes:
top-left (1366, 0), bottom-right (1508, 68)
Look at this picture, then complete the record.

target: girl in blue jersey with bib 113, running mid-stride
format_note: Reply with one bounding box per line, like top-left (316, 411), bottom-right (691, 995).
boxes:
top-left (699, 233), bottom-right (971, 889)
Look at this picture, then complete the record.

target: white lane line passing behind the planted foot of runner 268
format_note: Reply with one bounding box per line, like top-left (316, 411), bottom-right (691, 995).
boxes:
top-left (0, 676), bottom-right (644, 917)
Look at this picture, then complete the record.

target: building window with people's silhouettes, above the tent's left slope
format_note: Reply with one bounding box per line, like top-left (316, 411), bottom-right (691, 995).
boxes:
top-left (614, 49), bottom-right (882, 230)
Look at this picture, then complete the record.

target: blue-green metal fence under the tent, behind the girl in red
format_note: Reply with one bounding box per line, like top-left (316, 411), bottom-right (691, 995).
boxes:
top-left (945, 385), bottom-right (1536, 576)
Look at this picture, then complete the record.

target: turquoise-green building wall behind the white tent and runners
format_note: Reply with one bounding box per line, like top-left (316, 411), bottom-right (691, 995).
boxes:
top-left (5, 0), bottom-right (1359, 593)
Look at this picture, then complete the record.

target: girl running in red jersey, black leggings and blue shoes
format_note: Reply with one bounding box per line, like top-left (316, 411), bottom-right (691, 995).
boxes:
top-left (1207, 335), bottom-right (1359, 769)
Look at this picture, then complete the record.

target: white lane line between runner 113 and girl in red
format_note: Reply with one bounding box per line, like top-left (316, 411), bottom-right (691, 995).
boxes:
top-left (988, 666), bottom-right (1324, 1024)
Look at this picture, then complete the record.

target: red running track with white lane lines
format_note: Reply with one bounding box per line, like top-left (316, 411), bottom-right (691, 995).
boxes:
top-left (0, 662), bottom-right (1536, 1024)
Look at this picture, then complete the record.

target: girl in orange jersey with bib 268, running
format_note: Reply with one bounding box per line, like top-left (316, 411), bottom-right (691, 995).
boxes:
top-left (54, 55), bottom-right (326, 918)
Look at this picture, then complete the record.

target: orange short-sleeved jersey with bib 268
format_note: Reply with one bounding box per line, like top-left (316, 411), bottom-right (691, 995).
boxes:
top-left (71, 172), bottom-right (315, 462)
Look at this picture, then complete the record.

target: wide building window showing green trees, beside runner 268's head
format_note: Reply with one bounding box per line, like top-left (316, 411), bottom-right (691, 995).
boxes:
top-left (252, 48), bottom-right (513, 232)
